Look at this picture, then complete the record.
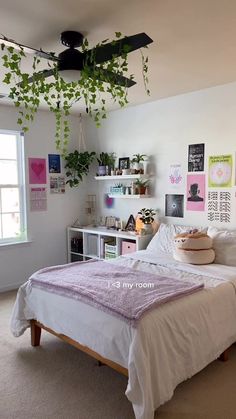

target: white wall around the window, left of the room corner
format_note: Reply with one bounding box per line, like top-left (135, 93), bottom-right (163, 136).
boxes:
top-left (0, 106), bottom-right (94, 291)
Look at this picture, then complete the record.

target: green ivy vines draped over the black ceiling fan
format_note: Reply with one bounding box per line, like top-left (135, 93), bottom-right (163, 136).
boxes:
top-left (1, 32), bottom-right (150, 156)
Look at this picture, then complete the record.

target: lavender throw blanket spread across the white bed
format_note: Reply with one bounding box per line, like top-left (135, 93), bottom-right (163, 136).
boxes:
top-left (30, 261), bottom-right (203, 326)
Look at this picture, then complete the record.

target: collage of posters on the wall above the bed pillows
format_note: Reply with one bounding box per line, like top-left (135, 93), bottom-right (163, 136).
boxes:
top-left (165, 143), bottom-right (235, 223)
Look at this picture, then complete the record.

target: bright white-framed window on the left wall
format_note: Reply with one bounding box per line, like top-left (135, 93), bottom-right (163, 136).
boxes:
top-left (0, 130), bottom-right (27, 244)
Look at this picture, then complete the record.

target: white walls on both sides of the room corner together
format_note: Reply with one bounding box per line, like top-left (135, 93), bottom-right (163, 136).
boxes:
top-left (0, 83), bottom-right (236, 291)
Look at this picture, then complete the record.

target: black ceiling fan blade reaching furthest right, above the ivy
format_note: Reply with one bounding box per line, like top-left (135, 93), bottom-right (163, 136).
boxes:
top-left (85, 32), bottom-right (153, 65)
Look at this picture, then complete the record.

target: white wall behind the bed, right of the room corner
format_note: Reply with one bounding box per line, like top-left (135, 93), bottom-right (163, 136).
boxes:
top-left (87, 83), bottom-right (236, 228)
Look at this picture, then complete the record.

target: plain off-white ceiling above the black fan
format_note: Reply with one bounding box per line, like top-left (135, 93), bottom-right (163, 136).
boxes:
top-left (0, 0), bottom-right (236, 111)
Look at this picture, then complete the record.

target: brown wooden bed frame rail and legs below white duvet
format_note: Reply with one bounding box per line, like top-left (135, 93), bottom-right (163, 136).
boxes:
top-left (30, 320), bottom-right (229, 377)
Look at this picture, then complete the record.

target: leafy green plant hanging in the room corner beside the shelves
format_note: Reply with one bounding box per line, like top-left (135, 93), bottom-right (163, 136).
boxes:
top-left (65, 150), bottom-right (96, 188)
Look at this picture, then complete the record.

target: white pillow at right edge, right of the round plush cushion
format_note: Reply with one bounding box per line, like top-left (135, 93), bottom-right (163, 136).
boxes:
top-left (207, 227), bottom-right (236, 266)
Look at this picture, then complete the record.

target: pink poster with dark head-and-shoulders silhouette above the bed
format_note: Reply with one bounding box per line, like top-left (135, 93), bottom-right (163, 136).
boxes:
top-left (187, 175), bottom-right (205, 211)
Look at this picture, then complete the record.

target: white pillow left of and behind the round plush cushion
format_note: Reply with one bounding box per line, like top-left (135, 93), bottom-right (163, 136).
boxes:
top-left (147, 223), bottom-right (207, 254)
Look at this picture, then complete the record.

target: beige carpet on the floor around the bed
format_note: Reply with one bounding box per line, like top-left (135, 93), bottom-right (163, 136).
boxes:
top-left (0, 292), bottom-right (236, 419)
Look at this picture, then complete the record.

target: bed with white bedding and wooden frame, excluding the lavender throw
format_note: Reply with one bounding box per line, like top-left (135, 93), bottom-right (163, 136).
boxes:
top-left (11, 224), bottom-right (236, 419)
